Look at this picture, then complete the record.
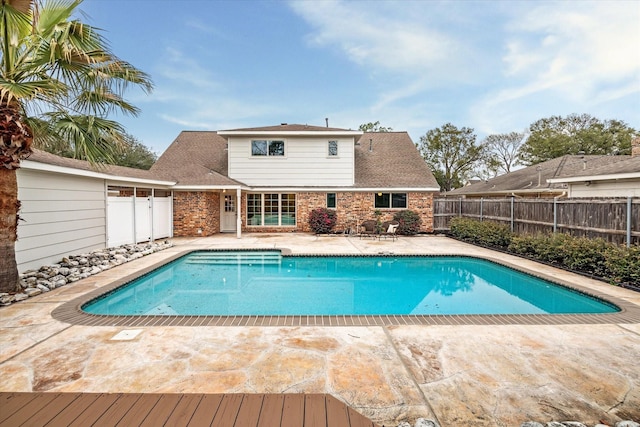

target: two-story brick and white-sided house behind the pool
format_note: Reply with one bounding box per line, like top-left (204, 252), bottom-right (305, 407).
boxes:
top-left (150, 124), bottom-right (439, 236)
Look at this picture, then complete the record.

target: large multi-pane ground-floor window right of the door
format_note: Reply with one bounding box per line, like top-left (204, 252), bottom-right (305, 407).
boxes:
top-left (247, 193), bottom-right (296, 227)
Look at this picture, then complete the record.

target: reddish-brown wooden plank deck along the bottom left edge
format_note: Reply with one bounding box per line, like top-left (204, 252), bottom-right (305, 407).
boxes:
top-left (0, 392), bottom-right (377, 427)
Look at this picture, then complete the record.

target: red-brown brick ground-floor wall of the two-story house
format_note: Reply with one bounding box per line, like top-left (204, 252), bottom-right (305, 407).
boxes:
top-left (173, 192), bottom-right (433, 237)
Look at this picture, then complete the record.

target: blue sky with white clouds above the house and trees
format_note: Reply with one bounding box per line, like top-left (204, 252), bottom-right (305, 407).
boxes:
top-left (79, 0), bottom-right (640, 154)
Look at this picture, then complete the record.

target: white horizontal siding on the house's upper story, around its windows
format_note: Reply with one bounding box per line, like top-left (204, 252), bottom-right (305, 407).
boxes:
top-left (228, 136), bottom-right (354, 186)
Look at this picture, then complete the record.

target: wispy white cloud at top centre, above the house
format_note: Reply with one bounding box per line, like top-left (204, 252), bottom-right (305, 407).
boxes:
top-left (291, 1), bottom-right (465, 79)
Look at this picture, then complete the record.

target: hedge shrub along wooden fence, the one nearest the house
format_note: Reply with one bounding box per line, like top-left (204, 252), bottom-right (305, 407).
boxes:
top-left (449, 217), bottom-right (513, 249)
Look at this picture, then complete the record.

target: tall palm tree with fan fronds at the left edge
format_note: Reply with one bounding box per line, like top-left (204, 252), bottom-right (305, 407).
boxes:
top-left (0, 0), bottom-right (152, 292)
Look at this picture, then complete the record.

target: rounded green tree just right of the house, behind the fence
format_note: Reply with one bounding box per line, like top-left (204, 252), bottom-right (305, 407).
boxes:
top-left (418, 123), bottom-right (486, 191)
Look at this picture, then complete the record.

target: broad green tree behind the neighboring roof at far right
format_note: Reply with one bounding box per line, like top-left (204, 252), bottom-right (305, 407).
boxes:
top-left (519, 114), bottom-right (637, 165)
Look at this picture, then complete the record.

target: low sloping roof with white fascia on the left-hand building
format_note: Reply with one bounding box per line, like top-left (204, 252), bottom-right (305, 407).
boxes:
top-left (21, 149), bottom-right (173, 185)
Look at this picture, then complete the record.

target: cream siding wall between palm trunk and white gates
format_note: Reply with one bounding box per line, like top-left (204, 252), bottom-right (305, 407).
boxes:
top-left (16, 169), bottom-right (106, 271)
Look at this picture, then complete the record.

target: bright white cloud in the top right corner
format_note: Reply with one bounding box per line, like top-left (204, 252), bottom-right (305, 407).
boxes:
top-left (504, 2), bottom-right (640, 100)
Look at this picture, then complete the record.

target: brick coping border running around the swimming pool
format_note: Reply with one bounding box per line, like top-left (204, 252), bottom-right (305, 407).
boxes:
top-left (51, 247), bottom-right (640, 327)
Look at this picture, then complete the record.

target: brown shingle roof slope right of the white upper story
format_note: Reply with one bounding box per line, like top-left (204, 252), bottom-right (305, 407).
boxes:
top-left (355, 132), bottom-right (440, 189)
